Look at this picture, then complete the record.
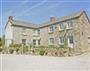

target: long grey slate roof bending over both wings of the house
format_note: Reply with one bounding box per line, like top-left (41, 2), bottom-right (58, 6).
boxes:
top-left (12, 10), bottom-right (85, 28)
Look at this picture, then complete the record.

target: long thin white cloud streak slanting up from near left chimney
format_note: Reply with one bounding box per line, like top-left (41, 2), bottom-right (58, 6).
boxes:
top-left (16, 0), bottom-right (47, 17)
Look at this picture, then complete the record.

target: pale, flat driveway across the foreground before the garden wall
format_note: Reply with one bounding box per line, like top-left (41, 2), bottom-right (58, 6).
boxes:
top-left (0, 55), bottom-right (90, 71)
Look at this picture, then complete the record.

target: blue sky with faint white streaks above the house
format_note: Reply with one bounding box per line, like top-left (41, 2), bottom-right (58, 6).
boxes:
top-left (0, 0), bottom-right (90, 36)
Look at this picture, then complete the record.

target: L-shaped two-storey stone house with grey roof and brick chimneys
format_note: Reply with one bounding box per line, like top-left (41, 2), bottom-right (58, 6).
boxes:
top-left (5, 11), bottom-right (90, 49)
